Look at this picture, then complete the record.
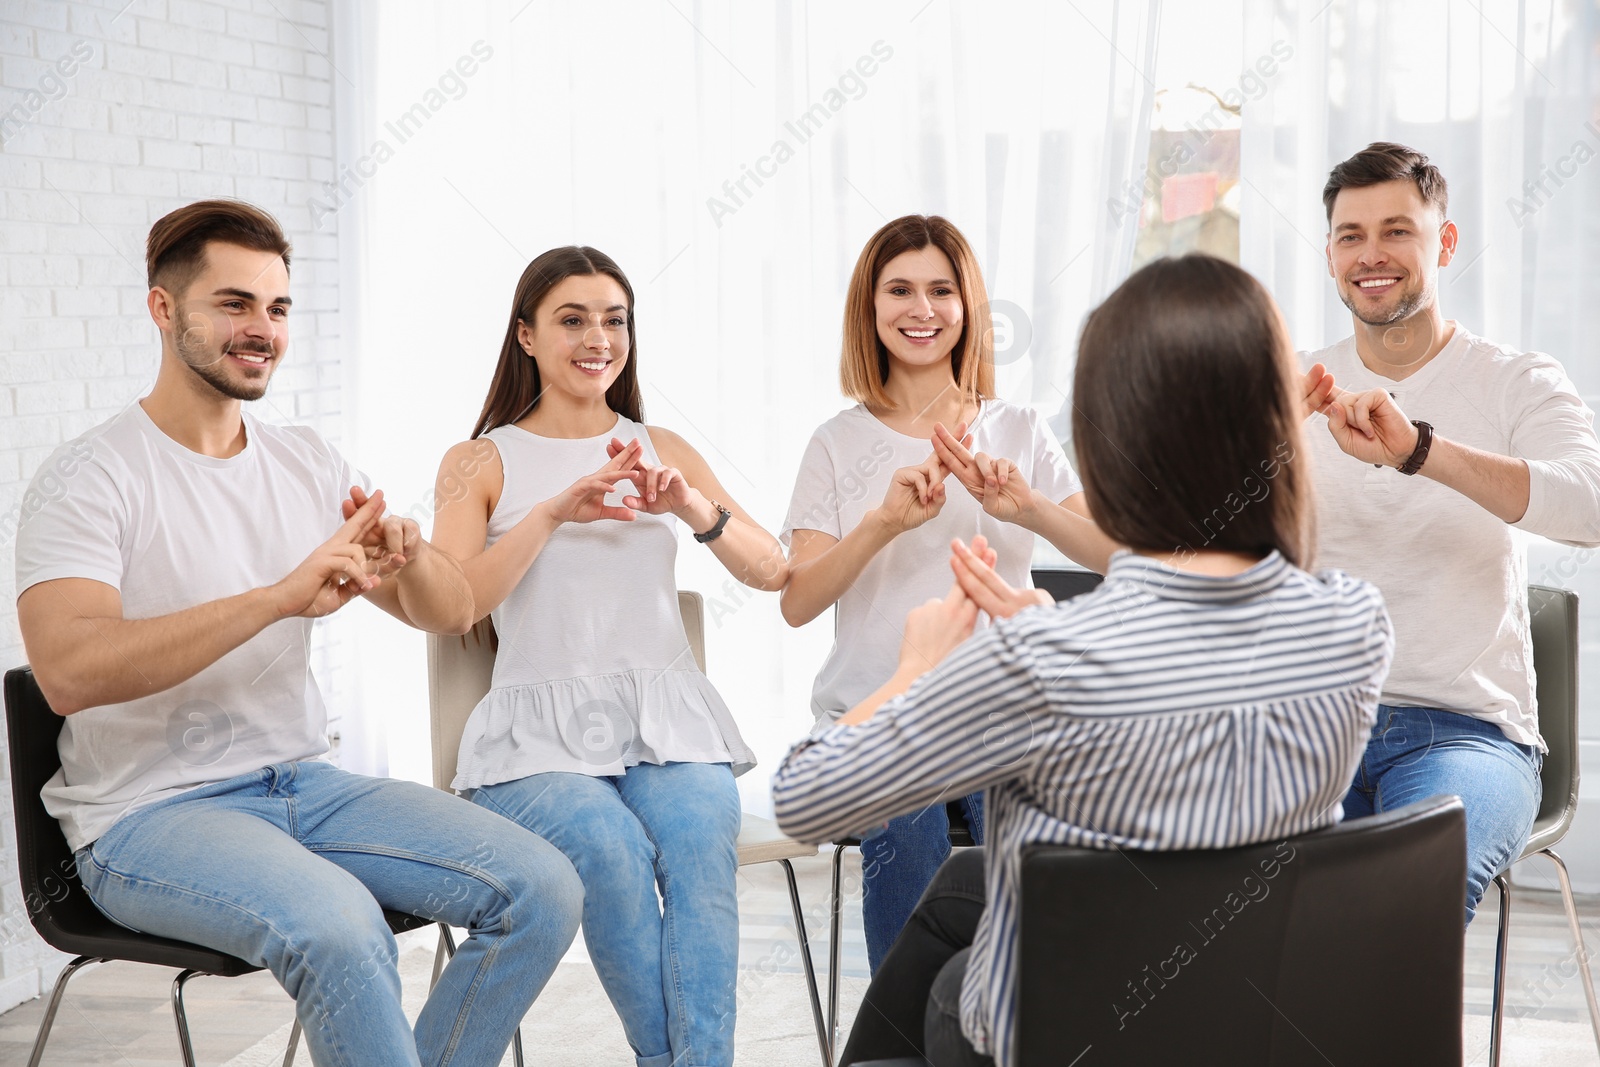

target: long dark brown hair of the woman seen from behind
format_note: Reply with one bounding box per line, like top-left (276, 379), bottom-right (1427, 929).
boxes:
top-left (1072, 256), bottom-right (1315, 566)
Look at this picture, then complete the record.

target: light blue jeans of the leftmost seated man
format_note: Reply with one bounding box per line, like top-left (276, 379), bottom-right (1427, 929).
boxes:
top-left (77, 763), bottom-right (582, 1067)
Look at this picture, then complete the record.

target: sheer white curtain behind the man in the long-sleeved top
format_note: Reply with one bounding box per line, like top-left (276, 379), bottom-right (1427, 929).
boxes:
top-left (1240, 0), bottom-right (1600, 891)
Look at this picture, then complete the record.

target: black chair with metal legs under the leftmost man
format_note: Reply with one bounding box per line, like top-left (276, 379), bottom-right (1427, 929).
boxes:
top-left (5, 667), bottom-right (430, 1067)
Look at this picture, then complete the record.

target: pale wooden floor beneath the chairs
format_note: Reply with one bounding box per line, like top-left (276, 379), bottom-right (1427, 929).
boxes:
top-left (0, 851), bottom-right (1600, 1067)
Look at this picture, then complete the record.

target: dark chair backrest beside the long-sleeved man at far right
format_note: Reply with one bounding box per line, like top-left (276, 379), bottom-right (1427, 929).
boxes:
top-left (1528, 585), bottom-right (1578, 840)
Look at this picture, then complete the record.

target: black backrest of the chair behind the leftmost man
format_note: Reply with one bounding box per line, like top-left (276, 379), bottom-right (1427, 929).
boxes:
top-left (5, 667), bottom-right (109, 944)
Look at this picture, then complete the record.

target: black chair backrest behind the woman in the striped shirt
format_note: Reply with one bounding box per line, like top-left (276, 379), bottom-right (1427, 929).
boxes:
top-left (1016, 797), bottom-right (1467, 1067)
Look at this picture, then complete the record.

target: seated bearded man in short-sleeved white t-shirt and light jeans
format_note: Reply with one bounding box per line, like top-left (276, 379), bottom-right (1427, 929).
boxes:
top-left (16, 200), bottom-right (582, 1067)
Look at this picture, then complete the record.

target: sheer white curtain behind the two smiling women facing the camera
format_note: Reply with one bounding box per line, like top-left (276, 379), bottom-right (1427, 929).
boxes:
top-left (331, 0), bottom-right (1158, 809)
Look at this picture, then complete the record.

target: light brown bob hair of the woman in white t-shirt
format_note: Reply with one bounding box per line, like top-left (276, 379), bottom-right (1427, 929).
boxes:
top-left (838, 214), bottom-right (995, 411)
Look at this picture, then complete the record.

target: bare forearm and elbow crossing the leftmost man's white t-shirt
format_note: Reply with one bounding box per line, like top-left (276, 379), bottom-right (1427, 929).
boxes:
top-left (18, 582), bottom-right (280, 715)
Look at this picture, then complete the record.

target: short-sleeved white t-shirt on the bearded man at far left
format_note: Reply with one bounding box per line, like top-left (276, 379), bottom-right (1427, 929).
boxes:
top-left (16, 403), bottom-right (366, 849)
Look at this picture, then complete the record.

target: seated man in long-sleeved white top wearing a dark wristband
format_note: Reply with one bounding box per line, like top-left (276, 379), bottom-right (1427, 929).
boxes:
top-left (1304, 142), bottom-right (1600, 923)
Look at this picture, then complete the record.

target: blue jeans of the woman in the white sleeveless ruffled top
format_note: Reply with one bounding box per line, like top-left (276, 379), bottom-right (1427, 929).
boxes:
top-left (472, 763), bottom-right (742, 1067)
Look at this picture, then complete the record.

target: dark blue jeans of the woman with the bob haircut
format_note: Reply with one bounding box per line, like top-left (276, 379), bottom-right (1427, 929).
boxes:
top-left (861, 793), bottom-right (984, 974)
